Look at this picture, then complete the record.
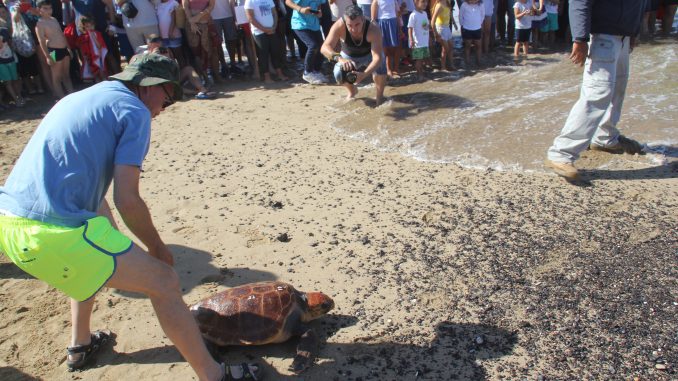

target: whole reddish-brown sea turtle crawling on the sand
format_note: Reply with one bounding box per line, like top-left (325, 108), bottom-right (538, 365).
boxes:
top-left (190, 282), bottom-right (334, 374)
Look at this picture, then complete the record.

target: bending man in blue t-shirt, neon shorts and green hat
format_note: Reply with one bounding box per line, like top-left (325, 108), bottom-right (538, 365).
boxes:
top-left (0, 54), bottom-right (257, 380)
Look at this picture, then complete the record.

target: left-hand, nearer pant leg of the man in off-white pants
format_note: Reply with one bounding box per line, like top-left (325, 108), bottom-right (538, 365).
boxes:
top-left (547, 34), bottom-right (621, 163)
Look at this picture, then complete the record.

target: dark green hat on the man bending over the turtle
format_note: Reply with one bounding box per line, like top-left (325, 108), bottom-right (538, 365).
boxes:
top-left (108, 53), bottom-right (184, 100)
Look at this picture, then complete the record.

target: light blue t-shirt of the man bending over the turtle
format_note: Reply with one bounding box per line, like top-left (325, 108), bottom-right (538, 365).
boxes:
top-left (0, 81), bottom-right (151, 227)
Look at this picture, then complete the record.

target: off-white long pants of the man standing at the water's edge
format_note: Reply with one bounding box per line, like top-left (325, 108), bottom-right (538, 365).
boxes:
top-left (547, 34), bottom-right (630, 162)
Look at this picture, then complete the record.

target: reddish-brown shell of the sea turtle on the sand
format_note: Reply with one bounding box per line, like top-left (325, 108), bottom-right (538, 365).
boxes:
top-left (190, 282), bottom-right (308, 346)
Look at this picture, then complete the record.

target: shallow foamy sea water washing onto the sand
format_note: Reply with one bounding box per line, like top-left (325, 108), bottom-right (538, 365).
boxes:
top-left (333, 36), bottom-right (678, 171)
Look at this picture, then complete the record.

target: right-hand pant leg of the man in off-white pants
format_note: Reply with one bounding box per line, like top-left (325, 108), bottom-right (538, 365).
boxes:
top-left (591, 37), bottom-right (630, 147)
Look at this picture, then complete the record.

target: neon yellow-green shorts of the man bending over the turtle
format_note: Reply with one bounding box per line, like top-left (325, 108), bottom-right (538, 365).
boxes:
top-left (0, 216), bottom-right (133, 301)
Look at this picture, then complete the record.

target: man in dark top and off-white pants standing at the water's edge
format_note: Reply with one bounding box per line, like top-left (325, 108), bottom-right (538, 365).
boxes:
top-left (545, 0), bottom-right (645, 180)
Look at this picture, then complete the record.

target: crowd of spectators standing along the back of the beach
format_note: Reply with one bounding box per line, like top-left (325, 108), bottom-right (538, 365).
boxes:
top-left (0, 0), bottom-right (677, 111)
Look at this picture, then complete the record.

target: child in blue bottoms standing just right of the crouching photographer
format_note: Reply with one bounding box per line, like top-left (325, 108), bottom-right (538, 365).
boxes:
top-left (371, 0), bottom-right (402, 78)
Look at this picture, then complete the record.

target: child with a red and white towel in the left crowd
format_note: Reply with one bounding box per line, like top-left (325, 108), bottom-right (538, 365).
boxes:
top-left (77, 16), bottom-right (108, 82)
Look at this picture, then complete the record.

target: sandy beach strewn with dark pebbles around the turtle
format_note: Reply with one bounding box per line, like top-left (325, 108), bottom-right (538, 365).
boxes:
top-left (0, 49), bottom-right (678, 381)
